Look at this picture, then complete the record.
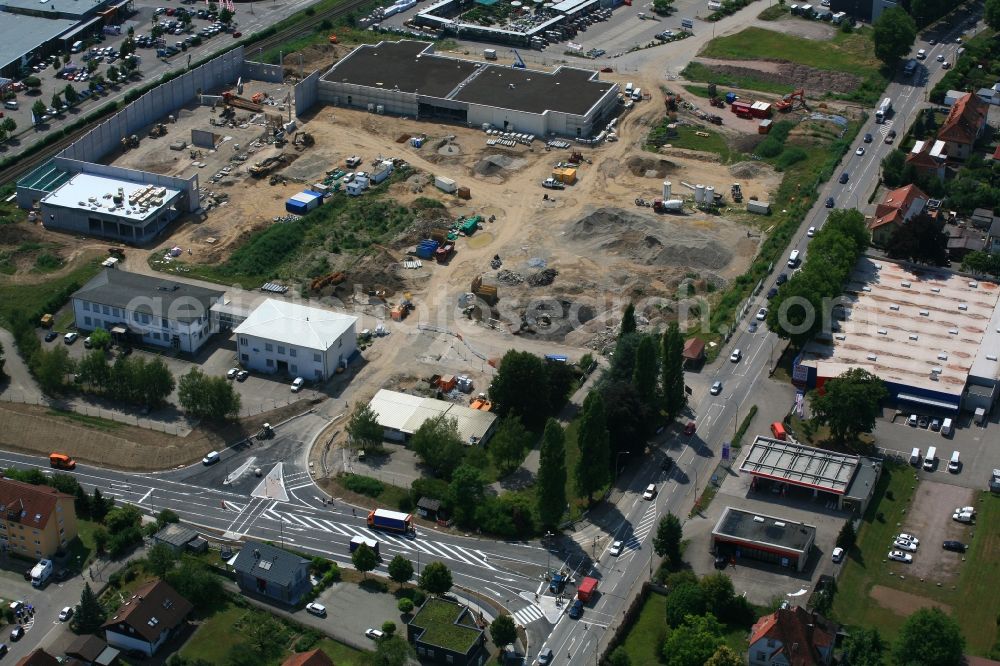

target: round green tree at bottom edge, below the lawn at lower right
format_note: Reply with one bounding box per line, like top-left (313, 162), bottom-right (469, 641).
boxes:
top-left (893, 607), bottom-right (965, 666)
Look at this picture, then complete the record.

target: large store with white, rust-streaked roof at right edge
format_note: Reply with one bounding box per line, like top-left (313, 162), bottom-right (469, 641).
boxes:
top-left (793, 257), bottom-right (1000, 414)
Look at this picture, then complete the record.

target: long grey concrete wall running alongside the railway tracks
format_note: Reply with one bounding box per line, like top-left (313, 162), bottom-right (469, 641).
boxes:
top-left (60, 46), bottom-right (243, 161)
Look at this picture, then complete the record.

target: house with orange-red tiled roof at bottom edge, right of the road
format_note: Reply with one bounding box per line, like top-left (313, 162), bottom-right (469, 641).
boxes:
top-left (749, 606), bottom-right (837, 666)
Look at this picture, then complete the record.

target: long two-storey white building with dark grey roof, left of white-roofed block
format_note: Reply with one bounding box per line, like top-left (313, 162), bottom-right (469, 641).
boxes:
top-left (73, 269), bottom-right (223, 354)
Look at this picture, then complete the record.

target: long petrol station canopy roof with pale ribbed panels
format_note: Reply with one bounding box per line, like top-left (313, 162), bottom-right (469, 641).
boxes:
top-left (740, 436), bottom-right (861, 495)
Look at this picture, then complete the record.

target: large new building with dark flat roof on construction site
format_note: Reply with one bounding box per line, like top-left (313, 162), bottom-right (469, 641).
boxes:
top-left (319, 40), bottom-right (618, 138)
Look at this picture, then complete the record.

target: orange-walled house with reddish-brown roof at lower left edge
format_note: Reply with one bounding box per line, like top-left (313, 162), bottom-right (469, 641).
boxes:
top-left (0, 478), bottom-right (76, 560)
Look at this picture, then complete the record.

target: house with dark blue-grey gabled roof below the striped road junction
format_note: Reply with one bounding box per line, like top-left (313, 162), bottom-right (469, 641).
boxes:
top-left (233, 541), bottom-right (312, 606)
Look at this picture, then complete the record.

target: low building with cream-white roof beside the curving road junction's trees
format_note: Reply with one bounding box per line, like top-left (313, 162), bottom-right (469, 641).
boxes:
top-left (368, 389), bottom-right (497, 445)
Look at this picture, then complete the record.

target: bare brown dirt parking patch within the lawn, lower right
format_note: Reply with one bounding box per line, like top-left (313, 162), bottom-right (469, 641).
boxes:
top-left (887, 481), bottom-right (973, 583)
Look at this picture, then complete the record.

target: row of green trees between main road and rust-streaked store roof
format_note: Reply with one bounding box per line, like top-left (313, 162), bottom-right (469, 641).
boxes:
top-left (767, 210), bottom-right (869, 346)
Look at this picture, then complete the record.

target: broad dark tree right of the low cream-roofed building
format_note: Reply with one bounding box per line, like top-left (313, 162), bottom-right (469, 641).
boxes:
top-left (490, 350), bottom-right (550, 429)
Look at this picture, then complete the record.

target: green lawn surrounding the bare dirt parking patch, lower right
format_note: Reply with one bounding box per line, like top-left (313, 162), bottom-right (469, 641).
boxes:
top-left (833, 466), bottom-right (1000, 655)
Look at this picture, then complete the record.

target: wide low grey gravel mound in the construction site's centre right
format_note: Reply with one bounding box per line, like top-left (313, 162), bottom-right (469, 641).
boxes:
top-left (565, 208), bottom-right (733, 271)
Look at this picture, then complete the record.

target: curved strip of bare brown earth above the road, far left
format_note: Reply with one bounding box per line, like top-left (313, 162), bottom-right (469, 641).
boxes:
top-left (0, 400), bottom-right (311, 471)
